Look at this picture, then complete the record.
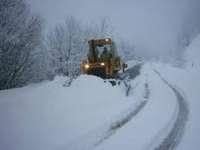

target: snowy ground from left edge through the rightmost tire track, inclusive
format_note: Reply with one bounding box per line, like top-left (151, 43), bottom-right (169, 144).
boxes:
top-left (0, 63), bottom-right (189, 150)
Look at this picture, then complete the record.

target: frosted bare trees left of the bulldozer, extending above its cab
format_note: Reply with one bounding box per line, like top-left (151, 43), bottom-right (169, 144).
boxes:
top-left (47, 16), bottom-right (111, 77)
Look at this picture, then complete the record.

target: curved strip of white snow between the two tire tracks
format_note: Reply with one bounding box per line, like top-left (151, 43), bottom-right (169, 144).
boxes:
top-left (96, 65), bottom-right (177, 150)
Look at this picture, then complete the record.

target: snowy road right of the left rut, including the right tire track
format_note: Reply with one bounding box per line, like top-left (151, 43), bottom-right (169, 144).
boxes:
top-left (96, 65), bottom-right (189, 150)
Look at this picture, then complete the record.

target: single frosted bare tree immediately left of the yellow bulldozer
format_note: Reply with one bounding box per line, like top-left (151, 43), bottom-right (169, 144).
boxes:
top-left (47, 17), bottom-right (84, 76)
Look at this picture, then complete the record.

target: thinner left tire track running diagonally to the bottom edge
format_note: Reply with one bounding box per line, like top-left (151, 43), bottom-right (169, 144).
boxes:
top-left (65, 98), bottom-right (147, 150)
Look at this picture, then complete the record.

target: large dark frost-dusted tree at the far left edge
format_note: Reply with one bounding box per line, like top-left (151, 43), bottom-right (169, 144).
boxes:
top-left (0, 0), bottom-right (42, 89)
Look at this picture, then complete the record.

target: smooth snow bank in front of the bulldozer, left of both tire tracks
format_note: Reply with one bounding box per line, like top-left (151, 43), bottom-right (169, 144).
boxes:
top-left (0, 75), bottom-right (144, 150)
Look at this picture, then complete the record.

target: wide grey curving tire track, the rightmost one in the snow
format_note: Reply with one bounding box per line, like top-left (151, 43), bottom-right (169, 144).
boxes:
top-left (154, 69), bottom-right (189, 150)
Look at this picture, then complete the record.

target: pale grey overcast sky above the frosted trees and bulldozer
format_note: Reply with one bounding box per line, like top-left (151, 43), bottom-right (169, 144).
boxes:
top-left (27, 0), bottom-right (200, 59)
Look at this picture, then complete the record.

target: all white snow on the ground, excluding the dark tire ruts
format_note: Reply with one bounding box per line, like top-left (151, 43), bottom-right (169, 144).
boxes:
top-left (0, 36), bottom-right (200, 150)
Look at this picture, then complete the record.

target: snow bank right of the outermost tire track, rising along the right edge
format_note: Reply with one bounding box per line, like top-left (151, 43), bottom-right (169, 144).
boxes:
top-left (152, 35), bottom-right (200, 150)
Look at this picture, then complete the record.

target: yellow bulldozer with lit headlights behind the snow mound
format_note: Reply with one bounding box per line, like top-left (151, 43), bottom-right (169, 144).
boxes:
top-left (81, 38), bottom-right (127, 79)
